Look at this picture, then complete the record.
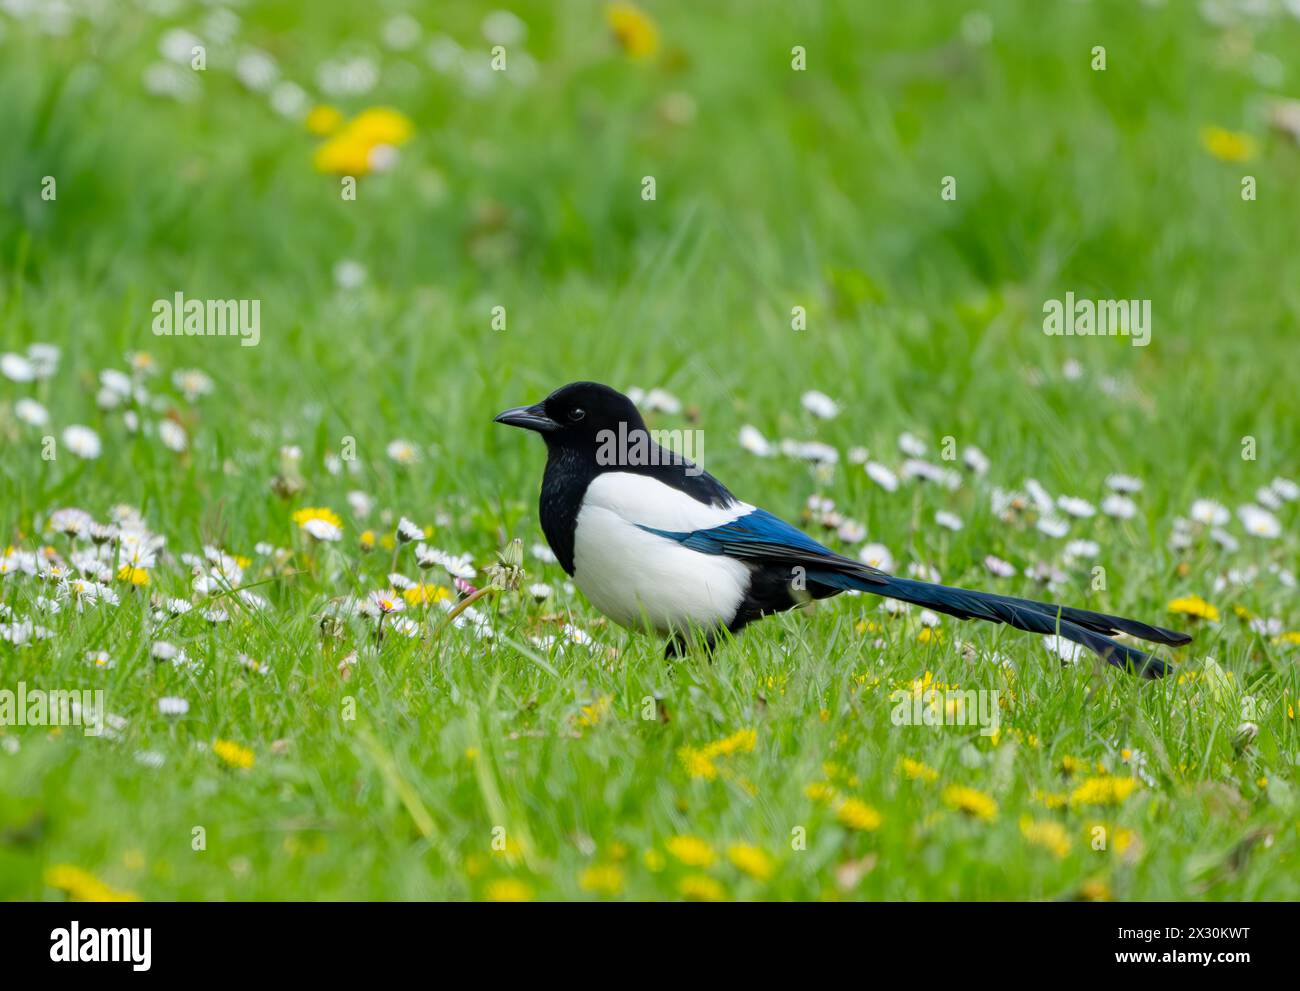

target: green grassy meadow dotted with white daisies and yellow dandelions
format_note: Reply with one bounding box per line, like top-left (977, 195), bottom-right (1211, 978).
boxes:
top-left (0, 0), bottom-right (1300, 900)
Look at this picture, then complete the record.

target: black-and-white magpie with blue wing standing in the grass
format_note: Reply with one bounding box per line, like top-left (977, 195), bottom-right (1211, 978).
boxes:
top-left (495, 381), bottom-right (1191, 678)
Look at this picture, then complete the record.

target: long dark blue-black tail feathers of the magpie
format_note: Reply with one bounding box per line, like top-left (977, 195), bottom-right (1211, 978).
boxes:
top-left (807, 570), bottom-right (1192, 678)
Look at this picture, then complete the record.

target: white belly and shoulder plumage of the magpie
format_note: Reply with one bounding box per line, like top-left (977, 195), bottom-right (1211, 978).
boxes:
top-left (573, 472), bottom-right (754, 633)
